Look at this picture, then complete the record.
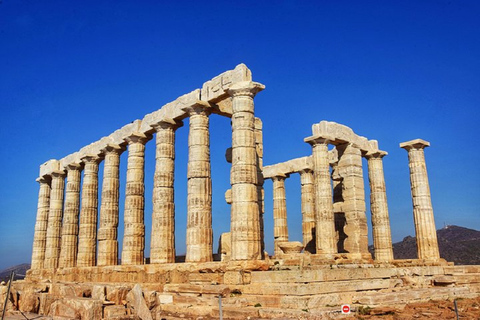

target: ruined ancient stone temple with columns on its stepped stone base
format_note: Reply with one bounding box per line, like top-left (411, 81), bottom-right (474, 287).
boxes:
top-left (6, 64), bottom-right (480, 319)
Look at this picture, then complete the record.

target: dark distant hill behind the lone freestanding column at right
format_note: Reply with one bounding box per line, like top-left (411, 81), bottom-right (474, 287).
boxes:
top-left (370, 226), bottom-right (480, 265)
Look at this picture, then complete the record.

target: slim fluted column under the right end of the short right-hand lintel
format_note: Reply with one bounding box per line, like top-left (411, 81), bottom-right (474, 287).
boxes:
top-left (365, 151), bottom-right (393, 262)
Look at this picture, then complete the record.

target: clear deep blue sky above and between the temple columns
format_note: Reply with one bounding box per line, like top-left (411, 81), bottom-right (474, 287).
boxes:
top-left (0, 0), bottom-right (480, 269)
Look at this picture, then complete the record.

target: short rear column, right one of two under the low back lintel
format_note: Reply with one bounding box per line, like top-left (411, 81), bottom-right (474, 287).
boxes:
top-left (299, 169), bottom-right (316, 253)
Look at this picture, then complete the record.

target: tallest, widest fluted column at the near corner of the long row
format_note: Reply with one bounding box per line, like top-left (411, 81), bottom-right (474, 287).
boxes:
top-left (228, 81), bottom-right (265, 260)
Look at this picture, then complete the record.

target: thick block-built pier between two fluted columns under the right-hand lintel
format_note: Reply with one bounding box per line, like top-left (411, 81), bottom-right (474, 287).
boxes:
top-left (336, 143), bottom-right (371, 259)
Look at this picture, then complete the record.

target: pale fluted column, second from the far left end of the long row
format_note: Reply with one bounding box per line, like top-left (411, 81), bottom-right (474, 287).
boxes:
top-left (43, 171), bottom-right (65, 269)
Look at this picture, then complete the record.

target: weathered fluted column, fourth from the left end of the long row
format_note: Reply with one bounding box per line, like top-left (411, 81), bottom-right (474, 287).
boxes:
top-left (77, 155), bottom-right (101, 267)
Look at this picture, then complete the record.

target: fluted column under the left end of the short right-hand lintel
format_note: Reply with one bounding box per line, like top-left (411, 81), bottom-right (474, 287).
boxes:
top-left (305, 136), bottom-right (337, 258)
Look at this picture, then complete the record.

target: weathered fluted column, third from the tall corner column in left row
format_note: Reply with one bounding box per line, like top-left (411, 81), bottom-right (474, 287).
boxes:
top-left (150, 119), bottom-right (181, 263)
